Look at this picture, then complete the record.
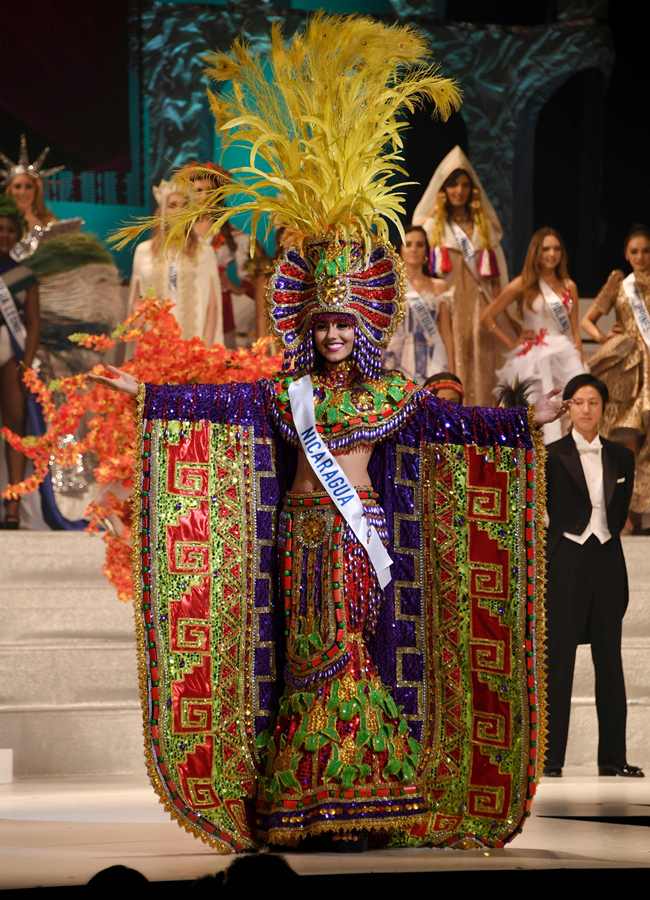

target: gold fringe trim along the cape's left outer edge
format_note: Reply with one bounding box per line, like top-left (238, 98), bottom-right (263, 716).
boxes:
top-left (131, 384), bottom-right (242, 855)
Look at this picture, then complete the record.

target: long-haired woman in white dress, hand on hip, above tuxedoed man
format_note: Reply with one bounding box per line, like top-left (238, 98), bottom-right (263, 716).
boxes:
top-left (481, 228), bottom-right (586, 444)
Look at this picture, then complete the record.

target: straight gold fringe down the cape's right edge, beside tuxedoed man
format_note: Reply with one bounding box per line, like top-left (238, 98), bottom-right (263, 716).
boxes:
top-left (528, 408), bottom-right (548, 782)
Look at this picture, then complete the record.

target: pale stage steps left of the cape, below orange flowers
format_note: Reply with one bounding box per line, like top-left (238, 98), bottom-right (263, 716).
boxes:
top-left (0, 531), bottom-right (144, 777)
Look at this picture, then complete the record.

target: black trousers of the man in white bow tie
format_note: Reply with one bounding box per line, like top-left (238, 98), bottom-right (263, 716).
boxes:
top-left (546, 535), bottom-right (628, 768)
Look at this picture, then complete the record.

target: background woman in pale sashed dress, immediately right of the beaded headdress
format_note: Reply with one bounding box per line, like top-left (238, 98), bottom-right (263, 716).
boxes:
top-left (384, 225), bottom-right (454, 384)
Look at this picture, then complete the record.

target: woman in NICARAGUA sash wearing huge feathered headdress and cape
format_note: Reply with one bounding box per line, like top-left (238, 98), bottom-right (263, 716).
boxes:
top-left (100, 15), bottom-right (557, 852)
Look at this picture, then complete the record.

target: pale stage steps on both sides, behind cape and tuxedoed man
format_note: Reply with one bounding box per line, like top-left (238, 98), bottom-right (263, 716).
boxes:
top-left (0, 532), bottom-right (650, 777)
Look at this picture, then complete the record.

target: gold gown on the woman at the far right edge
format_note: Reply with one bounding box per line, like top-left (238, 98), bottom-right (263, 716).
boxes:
top-left (589, 276), bottom-right (650, 513)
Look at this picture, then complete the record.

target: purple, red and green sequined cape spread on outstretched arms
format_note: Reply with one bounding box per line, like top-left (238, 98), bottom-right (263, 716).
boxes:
top-left (133, 377), bottom-right (545, 853)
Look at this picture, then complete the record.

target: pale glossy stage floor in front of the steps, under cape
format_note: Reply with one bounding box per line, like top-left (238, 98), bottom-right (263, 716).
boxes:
top-left (0, 769), bottom-right (650, 890)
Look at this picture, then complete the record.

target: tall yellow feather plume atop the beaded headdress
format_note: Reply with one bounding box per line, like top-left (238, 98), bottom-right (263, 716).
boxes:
top-left (111, 13), bottom-right (460, 253)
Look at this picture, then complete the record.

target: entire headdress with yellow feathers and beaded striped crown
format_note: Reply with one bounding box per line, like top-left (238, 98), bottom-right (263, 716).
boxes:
top-left (111, 13), bottom-right (460, 375)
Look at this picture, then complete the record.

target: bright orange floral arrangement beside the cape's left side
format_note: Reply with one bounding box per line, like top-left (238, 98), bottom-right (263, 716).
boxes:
top-left (0, 299), bottom-right (280, 601)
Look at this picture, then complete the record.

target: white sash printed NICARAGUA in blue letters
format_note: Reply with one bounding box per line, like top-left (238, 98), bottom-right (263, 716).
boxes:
top-left (289, 375), bottom-right (393, 589)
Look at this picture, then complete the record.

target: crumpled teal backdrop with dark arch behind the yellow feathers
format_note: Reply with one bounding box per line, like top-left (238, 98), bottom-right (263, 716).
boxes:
top-left (50, 0), bottom-right (613, 277)
